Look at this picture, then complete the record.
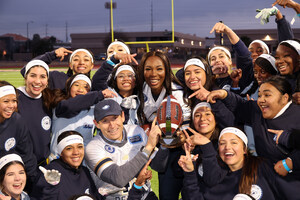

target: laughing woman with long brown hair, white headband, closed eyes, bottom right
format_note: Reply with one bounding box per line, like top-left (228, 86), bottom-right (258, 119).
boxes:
top-left (179, 127), bottom-right (288, 200)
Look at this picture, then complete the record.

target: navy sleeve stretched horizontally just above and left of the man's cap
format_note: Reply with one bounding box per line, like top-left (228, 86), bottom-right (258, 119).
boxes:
top-left (55, 91), bottom-right (104, 118)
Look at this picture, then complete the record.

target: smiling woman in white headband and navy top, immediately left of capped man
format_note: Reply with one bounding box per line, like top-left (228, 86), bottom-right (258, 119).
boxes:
top-left (32, 131), bottom-right (101, 200)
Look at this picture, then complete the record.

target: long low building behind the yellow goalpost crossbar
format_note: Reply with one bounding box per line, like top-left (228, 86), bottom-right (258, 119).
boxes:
top-left (71, 31), bottom-right (207, 60)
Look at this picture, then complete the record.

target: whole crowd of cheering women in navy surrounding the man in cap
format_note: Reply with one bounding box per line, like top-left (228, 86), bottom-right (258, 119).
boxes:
top-left (0, 1), bottom-right (300, 200)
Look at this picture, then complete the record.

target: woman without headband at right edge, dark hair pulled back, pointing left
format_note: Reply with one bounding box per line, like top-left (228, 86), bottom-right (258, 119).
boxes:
top-left (208, 76), bottom-right (300, 199)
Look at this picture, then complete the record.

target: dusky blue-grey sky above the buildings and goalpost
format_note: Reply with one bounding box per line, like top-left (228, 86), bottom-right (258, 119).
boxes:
top-left (0, 0), bottom-right (300, 41)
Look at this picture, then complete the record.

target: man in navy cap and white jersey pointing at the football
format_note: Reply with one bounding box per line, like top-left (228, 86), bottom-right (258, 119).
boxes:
top-left (86, 99), bottom-right (161, 200)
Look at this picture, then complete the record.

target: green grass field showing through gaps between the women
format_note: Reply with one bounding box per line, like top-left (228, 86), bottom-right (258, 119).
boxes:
top-left (0, 68), bottom-right (185, 196)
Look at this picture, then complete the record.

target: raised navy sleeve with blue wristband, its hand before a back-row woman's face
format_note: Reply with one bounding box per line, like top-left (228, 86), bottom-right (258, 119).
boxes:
top-left (92, 56), bottom-right (120, 91)
